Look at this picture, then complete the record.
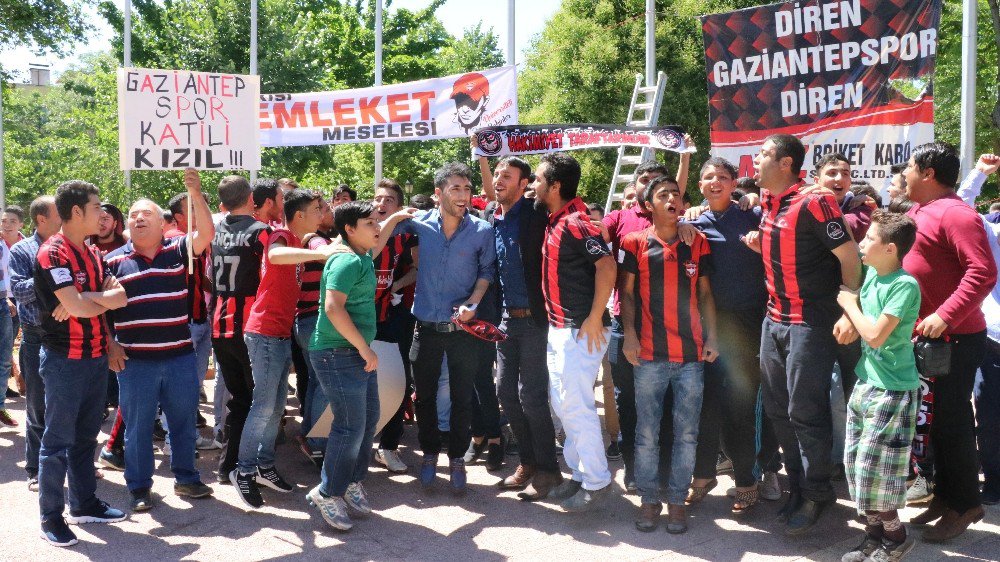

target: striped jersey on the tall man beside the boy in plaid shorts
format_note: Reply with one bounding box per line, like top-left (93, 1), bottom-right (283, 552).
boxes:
top-left (760, 183), bottom-right (851, 326)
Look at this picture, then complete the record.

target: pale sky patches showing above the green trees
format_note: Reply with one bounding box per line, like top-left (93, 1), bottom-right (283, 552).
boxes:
top-left (0, 0), bottom-right (560, 81)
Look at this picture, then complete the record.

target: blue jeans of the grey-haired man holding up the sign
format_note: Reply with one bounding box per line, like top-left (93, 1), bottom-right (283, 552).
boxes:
top-left (118, 352), bottom-right (200, 491)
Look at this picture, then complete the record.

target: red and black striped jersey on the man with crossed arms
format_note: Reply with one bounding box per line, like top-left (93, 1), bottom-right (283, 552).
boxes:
top-left (34, 232), bottom-right (108, 359)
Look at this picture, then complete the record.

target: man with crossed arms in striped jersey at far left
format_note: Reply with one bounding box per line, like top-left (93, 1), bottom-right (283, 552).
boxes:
top-left (34, 180), bottom-right (127, 546)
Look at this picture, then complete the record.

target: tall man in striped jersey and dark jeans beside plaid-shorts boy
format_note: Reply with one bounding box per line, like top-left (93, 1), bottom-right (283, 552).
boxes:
top-left (745, 135), bottom-right (861, 535)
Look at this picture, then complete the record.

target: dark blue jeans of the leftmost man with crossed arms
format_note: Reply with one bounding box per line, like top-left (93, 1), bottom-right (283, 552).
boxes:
top-left (38, 347), bottom-right (108, 521)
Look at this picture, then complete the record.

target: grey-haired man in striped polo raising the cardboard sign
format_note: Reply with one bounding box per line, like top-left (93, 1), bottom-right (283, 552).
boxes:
top-left (104, 168), bottom-right (215, 512)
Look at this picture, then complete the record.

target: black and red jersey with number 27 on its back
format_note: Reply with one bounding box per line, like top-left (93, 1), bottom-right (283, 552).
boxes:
top-left (212, 215), bottom-right (271, 338)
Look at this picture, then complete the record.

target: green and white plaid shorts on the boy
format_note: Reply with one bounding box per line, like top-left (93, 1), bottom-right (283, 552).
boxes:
top-left (844, 381), bottom-right (920, 514)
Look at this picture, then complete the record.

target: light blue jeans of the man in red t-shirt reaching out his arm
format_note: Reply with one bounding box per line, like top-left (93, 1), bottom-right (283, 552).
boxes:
top-left (237, 332), bottom-right (292, 474)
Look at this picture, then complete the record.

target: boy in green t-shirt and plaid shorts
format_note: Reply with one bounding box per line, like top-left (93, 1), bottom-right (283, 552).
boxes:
top-left (837, 211), bottom-right (920, 562)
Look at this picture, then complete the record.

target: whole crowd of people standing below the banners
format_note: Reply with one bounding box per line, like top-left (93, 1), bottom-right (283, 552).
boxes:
top-left (0, 135), bottom-right (1000, 562)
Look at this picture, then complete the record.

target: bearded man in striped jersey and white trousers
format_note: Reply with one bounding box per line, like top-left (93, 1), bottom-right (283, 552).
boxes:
top-left (534, 152), bottom-right (616, 511)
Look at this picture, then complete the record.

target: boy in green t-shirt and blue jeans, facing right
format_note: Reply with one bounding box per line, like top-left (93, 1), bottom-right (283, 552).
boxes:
top-left (306, 201), bottom-right (379, 531)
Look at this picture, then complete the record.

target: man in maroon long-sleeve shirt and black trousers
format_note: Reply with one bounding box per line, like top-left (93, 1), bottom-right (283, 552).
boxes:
top-left (903, 143), bottom-right (997, 542)
